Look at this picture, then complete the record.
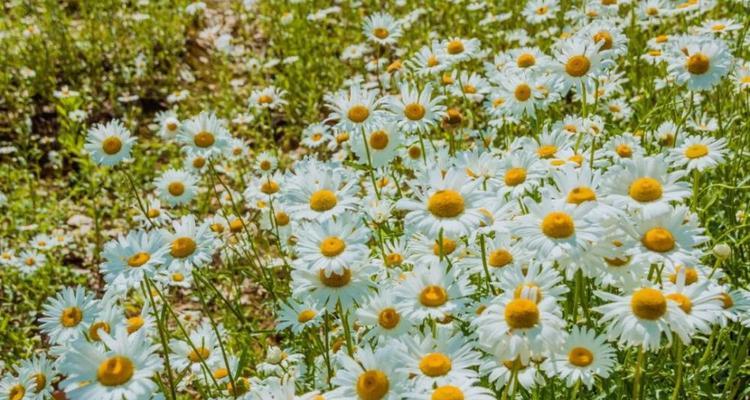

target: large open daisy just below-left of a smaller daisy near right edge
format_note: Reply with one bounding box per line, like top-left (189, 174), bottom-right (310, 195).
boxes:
top-left (605, 156), bottom-right (690, 217)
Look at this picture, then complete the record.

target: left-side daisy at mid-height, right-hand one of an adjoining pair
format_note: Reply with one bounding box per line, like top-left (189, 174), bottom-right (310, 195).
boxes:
top-left (162, 214), bottom-right (217, 267)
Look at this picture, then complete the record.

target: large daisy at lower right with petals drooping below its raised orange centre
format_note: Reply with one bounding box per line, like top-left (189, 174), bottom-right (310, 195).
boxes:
top-left (594, 287), bottom-right (691, 350)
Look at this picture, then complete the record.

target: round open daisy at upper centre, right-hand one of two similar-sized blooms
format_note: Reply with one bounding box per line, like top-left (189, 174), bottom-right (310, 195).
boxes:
top-left (388, 83), bottom-right (446, 132)
